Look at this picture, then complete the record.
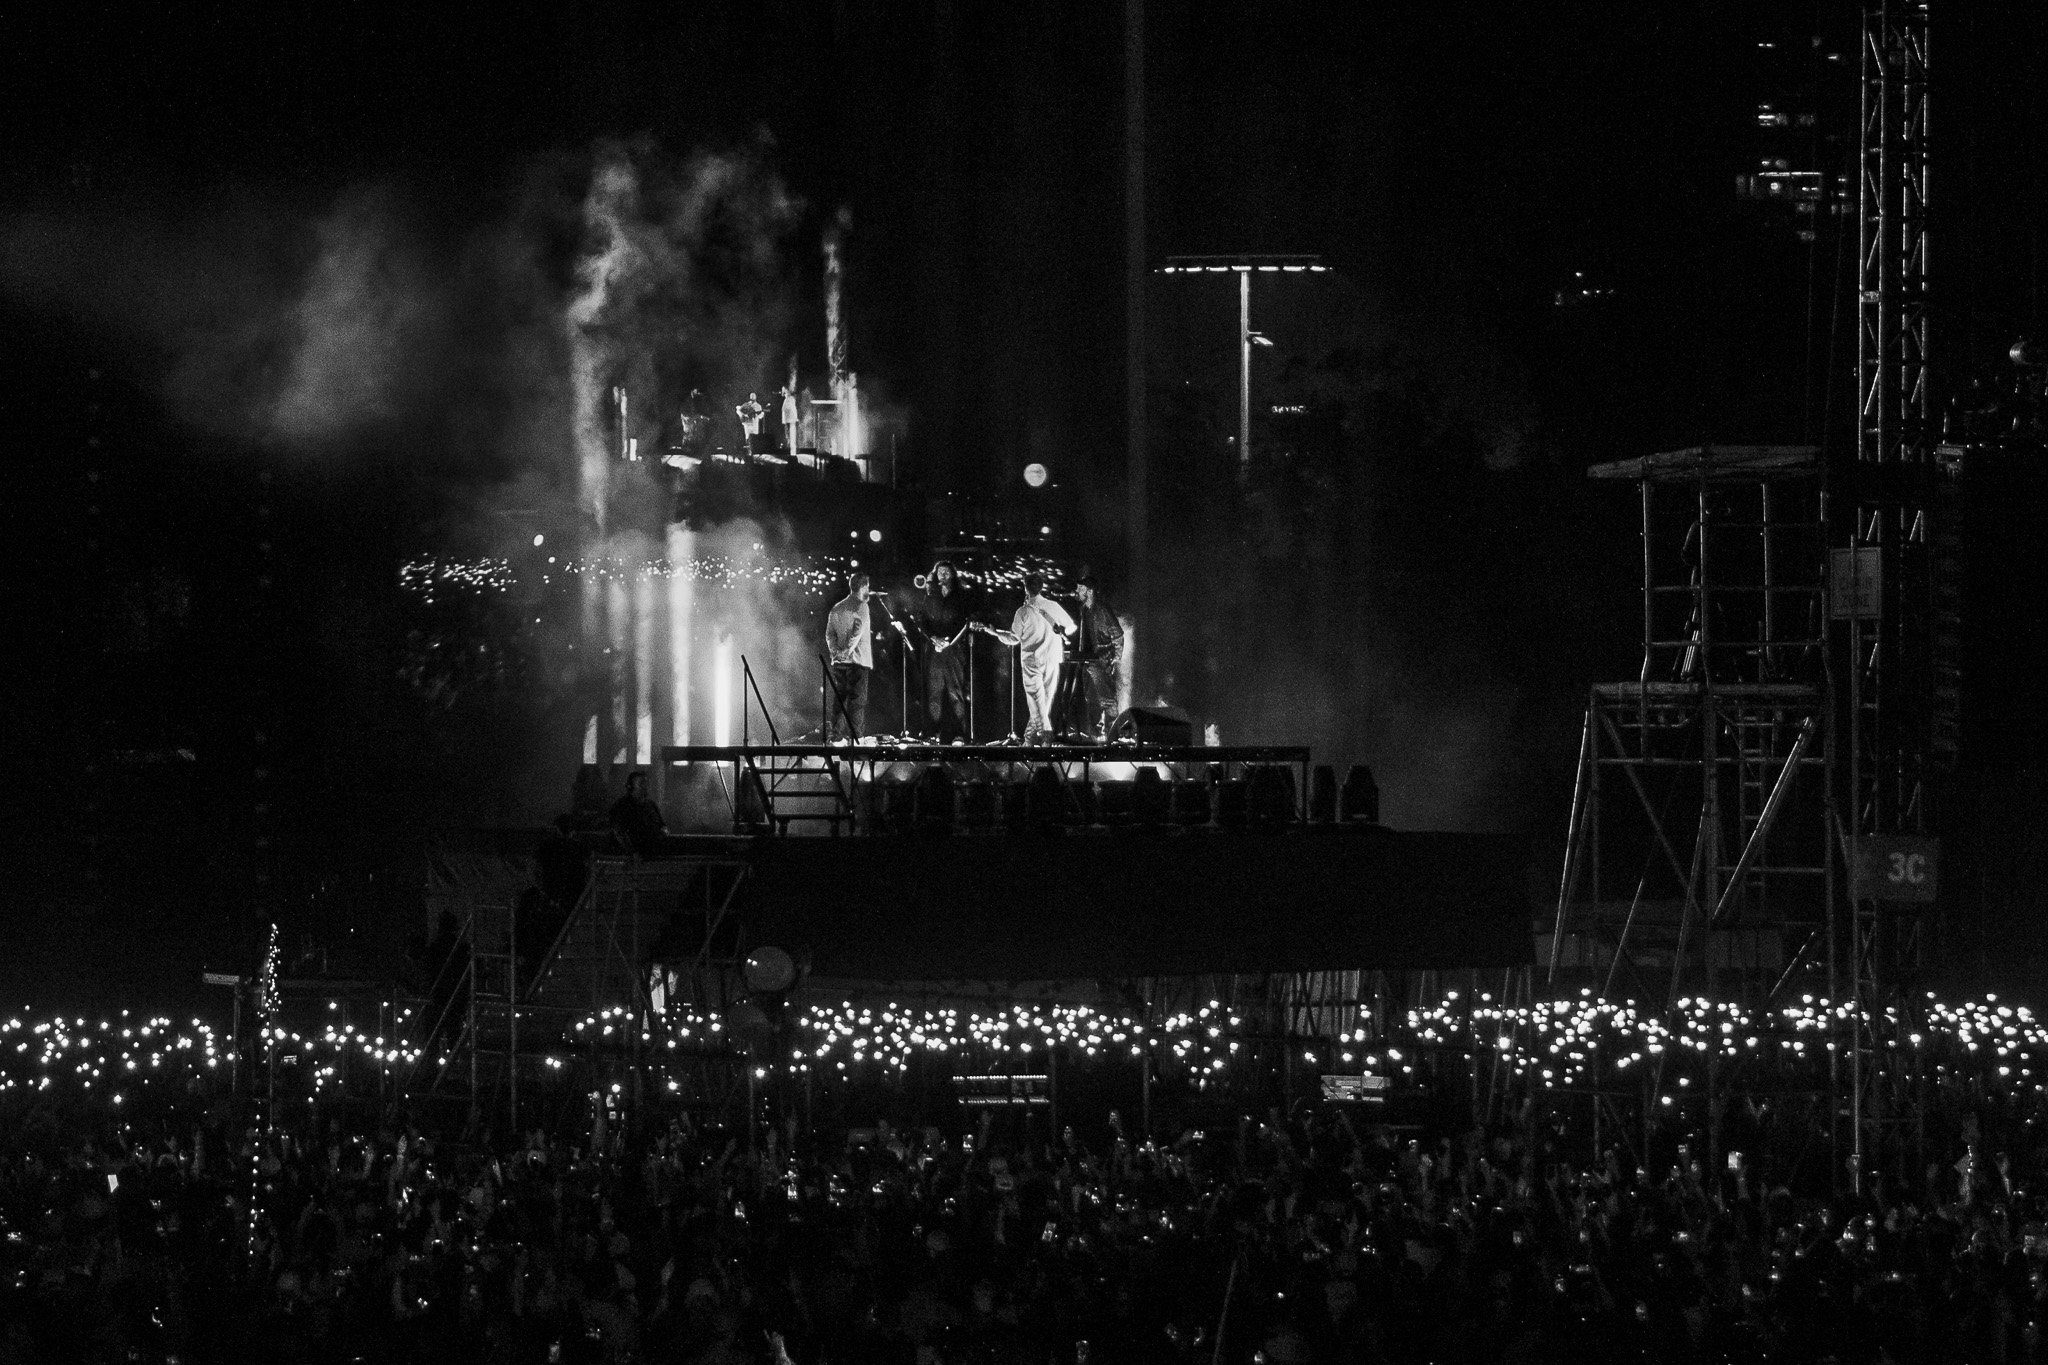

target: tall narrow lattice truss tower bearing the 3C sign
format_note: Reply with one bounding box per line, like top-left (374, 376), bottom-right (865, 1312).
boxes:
top-left (1831, 0), bottom-right (1956, 1189)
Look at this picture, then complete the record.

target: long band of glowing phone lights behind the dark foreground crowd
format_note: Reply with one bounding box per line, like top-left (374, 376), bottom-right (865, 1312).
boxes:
top-left (0, 990), bottom-right (2048, 1105)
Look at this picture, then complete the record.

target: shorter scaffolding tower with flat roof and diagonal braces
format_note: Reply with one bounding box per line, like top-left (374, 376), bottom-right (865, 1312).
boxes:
top-left (1542, 446), bottom-right (1833, 1005)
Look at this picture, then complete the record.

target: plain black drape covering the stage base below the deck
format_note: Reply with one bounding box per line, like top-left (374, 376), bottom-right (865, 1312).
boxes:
top-left (729, 829), bottom-right (1532, 980)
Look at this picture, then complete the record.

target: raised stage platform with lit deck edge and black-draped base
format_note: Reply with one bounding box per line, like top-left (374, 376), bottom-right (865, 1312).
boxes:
top-left (569, 743), bottom-right (1534, 980)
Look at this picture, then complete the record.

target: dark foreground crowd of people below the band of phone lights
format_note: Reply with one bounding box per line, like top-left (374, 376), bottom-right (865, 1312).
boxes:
top-left (0, 1080), bottom-right (2048, 1365)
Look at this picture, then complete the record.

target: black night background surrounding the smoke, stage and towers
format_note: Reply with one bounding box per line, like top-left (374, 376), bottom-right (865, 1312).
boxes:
top-left (0, 0), bottom-right (2048, 1003)
